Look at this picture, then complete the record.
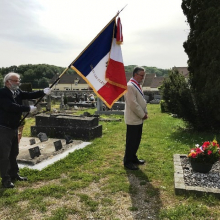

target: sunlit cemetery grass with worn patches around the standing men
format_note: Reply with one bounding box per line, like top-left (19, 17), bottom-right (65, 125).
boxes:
top-left (0, 105), bottom-right (220, 220)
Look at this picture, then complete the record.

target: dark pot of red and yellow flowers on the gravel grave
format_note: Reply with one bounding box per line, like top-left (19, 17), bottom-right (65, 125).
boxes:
top-left (188, 139), bottom-right (220, 173)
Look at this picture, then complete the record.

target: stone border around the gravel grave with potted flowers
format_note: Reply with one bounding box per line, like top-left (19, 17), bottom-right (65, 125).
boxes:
top-left (173, 154), bottom-right (220, 198)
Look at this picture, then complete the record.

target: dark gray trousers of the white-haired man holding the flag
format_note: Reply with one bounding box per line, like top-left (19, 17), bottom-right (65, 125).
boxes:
top-left (0, 127), bottom-right (19, 182)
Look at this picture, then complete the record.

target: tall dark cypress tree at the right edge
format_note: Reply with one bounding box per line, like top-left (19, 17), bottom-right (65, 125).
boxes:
top-left (182, 0), bottom-right (220, 130)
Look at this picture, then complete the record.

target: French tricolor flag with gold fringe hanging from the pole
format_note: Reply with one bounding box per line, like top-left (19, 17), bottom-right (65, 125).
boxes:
top-left (70, 17), bottom-right (127, 108)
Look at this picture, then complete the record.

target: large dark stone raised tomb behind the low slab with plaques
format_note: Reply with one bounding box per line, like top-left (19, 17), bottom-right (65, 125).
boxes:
top-left (31, 114), bottom-right (102, 141)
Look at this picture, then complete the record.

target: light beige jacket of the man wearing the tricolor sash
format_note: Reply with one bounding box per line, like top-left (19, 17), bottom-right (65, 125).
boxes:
top-left (124, 82), bottom-right (147, 125)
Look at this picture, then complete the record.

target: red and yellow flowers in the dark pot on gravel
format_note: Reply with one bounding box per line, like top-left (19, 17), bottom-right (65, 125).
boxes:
top-left (188, 140), bottom-right (220, 164)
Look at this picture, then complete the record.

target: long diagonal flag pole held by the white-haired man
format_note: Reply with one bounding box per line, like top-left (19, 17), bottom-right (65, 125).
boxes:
top-left (19, 5), bottom-right (127, 126)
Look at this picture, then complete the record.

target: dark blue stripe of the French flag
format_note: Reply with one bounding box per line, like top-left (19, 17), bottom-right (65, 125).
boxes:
top-left (72, 20), bottom-right (115, 77)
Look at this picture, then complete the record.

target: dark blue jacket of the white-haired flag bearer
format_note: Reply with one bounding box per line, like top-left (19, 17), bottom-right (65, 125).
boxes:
top-left (0, 87), bottom-right (44, 129)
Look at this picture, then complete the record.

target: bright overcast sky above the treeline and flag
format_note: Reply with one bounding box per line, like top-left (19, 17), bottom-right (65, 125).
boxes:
top-left (0, 0), bottom-right (189, 69)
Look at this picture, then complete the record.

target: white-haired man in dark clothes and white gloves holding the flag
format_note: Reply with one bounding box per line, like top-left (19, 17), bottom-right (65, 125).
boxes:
top-left (0, 73), bottom-right (51, 188)
